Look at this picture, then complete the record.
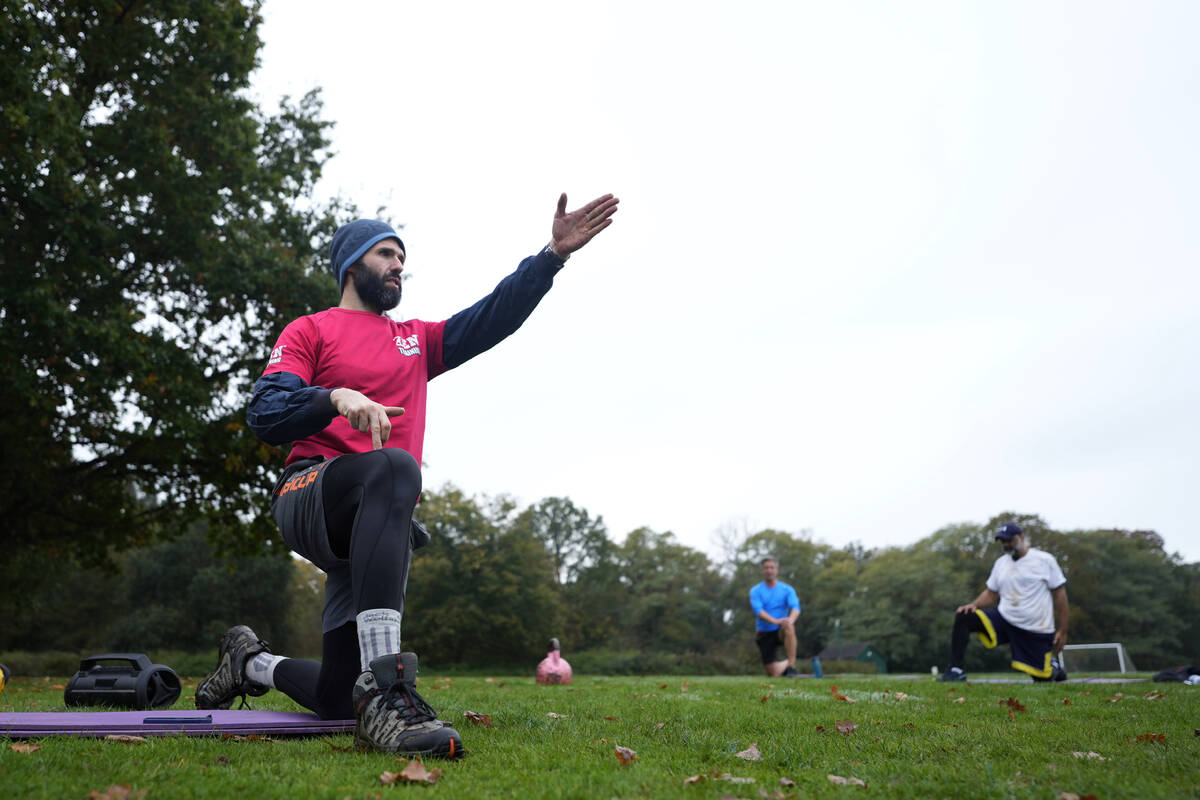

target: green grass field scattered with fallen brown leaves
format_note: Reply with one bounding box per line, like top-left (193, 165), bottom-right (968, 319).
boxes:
top-left (0, 674), bottom-right (1200, 800)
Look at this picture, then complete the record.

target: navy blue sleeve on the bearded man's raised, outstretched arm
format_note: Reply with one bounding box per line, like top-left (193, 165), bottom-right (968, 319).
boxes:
top-left (442, 247), bottom-right (563, 369)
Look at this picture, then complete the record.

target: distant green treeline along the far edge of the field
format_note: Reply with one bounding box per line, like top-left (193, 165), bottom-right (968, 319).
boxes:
top-left (0, 486), bottom-right (1200, 673)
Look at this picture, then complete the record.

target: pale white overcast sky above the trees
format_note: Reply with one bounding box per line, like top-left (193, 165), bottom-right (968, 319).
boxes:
top-left (248, 0), bottom-right (1200, 561)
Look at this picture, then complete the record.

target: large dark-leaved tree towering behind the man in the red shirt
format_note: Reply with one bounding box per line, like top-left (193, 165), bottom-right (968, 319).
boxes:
top-left (0, 0), bottom-right (337, 563)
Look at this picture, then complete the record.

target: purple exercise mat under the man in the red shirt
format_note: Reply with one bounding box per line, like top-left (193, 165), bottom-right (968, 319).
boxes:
top-left (0, 710), bottom-right (354, 739)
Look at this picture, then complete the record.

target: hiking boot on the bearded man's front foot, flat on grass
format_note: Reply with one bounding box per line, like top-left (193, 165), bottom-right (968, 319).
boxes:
top-left (352, 652), bottom-right (463, 758)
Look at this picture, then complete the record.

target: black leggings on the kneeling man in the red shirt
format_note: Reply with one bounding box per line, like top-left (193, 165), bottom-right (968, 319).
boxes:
top-left (275, 447), bottom-right (421, 720)
